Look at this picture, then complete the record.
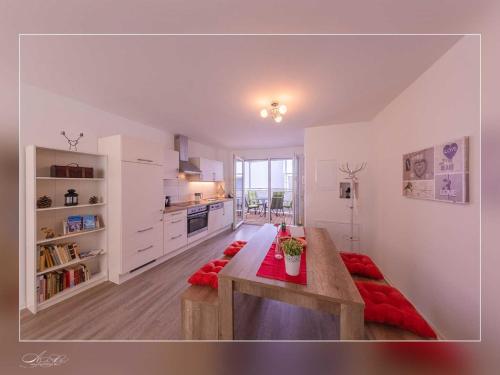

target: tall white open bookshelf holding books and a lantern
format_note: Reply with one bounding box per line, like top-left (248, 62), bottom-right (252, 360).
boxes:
top-left (26, 145), bottom-right (108, 313)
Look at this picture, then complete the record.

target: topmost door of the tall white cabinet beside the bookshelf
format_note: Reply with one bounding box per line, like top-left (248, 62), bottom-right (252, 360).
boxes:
top-left (118, 135), bottom-right (165, 165)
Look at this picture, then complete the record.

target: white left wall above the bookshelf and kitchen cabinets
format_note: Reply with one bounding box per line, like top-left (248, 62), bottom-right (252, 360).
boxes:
top-left (19, 84), bottom-right (227, 308)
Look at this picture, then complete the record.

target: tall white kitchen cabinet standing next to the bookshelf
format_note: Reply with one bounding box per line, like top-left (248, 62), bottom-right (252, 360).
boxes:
top-left (98, 135), bottom-right (164, 283)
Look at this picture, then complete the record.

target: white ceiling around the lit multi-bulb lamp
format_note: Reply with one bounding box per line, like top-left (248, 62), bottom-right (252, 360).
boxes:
top-left (21, 35), bottom-right (459, 148)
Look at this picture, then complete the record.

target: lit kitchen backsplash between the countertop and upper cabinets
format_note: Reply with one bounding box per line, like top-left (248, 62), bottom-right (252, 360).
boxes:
top-left (163, 178), bottom-right (223, 203)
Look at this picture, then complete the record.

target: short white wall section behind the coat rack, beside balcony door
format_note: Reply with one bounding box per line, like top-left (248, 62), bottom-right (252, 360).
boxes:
top-left (304, 122), bottom-right (372, 252)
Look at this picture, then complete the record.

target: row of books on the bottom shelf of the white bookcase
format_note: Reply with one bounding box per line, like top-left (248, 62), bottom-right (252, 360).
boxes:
top-left (36, 264), bottom-right (91, 303)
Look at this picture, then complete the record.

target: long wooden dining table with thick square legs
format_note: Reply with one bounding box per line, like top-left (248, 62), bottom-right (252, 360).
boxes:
top-left (218, 224), bottom-right (365, 340)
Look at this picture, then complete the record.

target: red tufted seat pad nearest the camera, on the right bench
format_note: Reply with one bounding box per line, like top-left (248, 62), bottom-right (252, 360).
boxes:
top-left (355, 281), bottom-right (437, 339)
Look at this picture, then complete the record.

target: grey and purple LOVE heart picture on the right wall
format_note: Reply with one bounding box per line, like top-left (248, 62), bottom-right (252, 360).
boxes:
top-left (403, 137), bottom-right (469, 203)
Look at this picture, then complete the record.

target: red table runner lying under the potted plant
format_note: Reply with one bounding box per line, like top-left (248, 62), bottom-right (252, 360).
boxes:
top-left (257, 231), bottom-right (307, 285)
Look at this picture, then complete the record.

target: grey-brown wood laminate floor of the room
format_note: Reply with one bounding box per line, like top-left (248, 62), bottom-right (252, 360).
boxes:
top-left (20, 225), bottom-right (339, 340)
